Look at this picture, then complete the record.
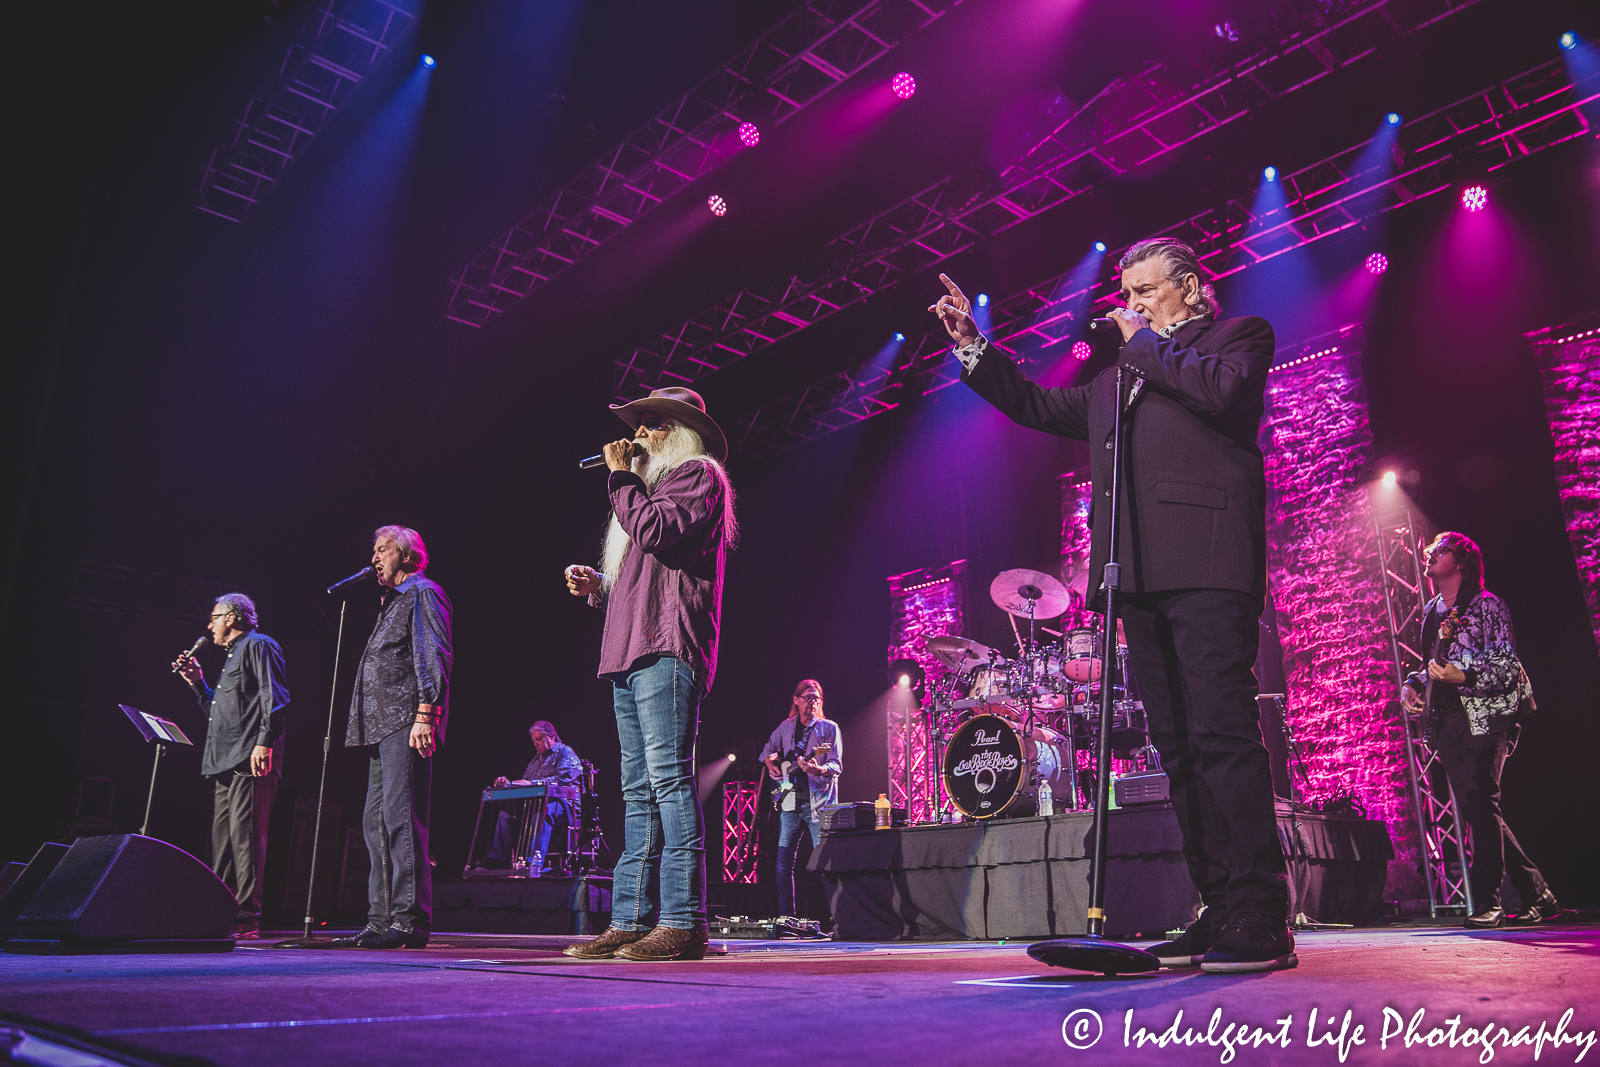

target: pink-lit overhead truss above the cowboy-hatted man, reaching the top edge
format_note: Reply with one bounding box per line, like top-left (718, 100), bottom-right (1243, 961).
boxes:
top-left (446, 0), bottom-right (962, 326)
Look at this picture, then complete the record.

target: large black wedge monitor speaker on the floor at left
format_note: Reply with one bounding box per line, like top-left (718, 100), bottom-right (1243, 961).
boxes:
top-left (16, 833), bottom-right (238, 941)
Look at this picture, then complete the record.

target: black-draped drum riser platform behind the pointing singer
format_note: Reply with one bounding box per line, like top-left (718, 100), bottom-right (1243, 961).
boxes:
top-left (811, 805), bottom-right (1394, 941)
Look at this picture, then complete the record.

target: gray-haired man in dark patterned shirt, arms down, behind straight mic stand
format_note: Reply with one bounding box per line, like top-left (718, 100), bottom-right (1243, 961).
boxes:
top-left (334, 526), bottom-right (453, 949)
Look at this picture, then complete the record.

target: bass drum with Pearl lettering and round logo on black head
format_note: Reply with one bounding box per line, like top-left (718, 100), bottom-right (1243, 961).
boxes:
top-left (944, 715), bottom-right (1070, 819)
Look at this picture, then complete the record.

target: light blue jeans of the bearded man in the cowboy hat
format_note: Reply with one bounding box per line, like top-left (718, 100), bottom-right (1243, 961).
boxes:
top-left (611, 656), bottom-right (706, 929)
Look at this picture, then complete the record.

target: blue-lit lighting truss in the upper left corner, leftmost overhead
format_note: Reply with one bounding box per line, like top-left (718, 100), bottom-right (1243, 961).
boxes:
top-left (195, 0), bottom-right (422, 222)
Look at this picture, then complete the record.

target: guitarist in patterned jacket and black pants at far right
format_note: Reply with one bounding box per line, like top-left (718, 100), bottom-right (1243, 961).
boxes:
top-left (1400, 533), bottom-right (1562, 929)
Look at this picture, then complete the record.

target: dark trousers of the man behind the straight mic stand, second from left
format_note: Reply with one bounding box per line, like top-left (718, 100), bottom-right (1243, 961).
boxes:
top-left (362, 723), bottom-right (434, 934)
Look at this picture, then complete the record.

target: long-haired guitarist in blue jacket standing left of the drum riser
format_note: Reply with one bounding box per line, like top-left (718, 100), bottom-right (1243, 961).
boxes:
top-left (762, 678), bottom-right (843, 918)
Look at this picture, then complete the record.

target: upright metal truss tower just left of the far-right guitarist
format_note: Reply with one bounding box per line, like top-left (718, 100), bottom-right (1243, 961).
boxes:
top-left (1373, 509), bottom-right (1477, 918)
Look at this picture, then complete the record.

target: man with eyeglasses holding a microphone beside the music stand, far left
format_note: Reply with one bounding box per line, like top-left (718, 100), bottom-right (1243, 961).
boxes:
top-left (173, 593), bottom-right (290, 941)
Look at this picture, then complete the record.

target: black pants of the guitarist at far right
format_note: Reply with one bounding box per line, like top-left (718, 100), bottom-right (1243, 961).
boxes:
top-left (1435, 712), bottom-right (1549, 912)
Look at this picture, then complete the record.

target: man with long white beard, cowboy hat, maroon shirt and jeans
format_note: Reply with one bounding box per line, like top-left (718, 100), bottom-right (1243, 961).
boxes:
top-left (566, 387), bottom-right (738, 961)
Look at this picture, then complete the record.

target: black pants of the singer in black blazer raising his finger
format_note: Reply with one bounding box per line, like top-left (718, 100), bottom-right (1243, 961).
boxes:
top-left (1120, 589), bottom-right (1290, 921)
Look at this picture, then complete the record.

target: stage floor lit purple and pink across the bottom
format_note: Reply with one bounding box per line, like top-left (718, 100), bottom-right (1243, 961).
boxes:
top-left (0, 915), bottom-right (1600, 1067)
